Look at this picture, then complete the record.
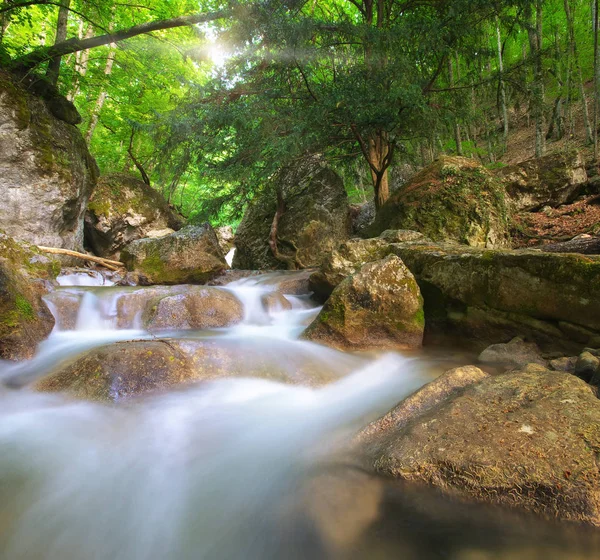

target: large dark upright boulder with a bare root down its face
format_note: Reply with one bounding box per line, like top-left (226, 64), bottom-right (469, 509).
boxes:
top-left (233, 156), bottom-right (349, 269)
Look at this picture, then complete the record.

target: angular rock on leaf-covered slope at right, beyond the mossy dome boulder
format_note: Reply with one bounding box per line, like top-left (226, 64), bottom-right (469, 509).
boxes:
top-left (498, 150), bottom-right (587, 211)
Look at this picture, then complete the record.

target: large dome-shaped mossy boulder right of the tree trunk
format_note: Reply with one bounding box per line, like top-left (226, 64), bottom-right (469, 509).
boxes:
top-left (367, 156), bottom-right (510, 247)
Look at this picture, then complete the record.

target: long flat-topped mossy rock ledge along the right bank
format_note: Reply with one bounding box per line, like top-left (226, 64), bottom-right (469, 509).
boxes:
top-left (391, 242), bottom-right (600, 353)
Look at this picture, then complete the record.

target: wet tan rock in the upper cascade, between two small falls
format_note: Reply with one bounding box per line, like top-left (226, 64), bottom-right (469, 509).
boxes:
top-left (144, 286), bottom-right (244, 331)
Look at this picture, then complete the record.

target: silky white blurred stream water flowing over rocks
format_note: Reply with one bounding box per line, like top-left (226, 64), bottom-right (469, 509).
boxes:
top-left (0, 274), bottom-right (600, 560)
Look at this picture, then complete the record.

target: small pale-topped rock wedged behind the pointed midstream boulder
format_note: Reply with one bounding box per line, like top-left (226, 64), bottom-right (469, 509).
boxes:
top-left (309, 238), bottom-right (391, 301)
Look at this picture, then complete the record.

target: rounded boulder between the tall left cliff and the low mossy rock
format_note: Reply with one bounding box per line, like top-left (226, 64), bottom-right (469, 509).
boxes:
top-left (85, 173), bottom-right (183, 257)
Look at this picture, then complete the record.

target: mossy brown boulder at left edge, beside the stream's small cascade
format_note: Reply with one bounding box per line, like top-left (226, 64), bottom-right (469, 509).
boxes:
top-left (0, 233), bottom-right (60, 360)
